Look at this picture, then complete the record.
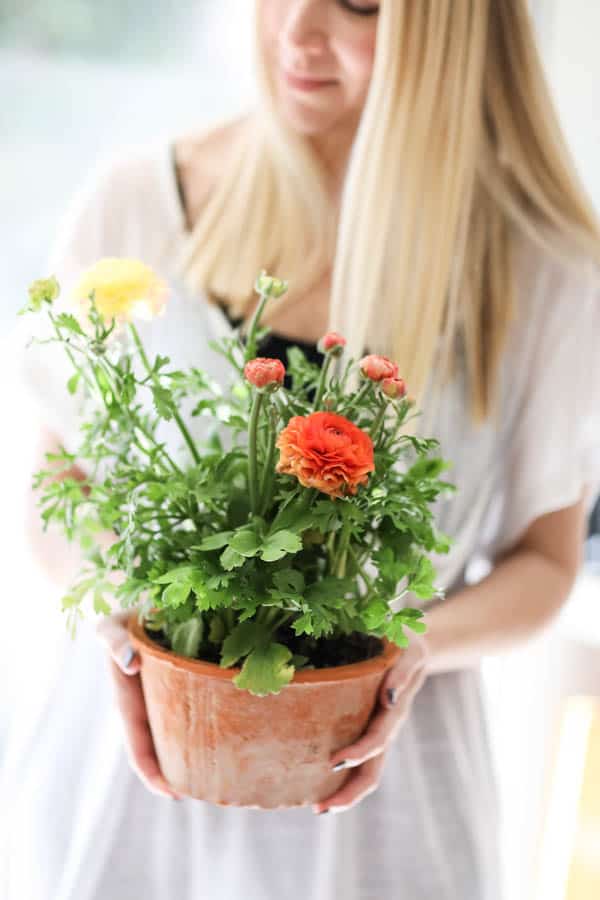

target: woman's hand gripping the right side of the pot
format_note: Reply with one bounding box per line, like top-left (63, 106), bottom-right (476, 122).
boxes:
top-left (313, 632), bottom-right (430, 813)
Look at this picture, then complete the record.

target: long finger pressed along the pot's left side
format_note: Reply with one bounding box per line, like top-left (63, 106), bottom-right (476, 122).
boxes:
top-left (110, 660), bottom-right (181, 799)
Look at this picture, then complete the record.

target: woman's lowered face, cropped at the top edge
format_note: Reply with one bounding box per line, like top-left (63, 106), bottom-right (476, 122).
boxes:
top-left (259, 0), bottom-right (379, 136)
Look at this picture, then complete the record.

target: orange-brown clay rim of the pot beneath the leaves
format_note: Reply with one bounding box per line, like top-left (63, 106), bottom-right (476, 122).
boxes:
top-left (127, 611), bottom-right (403, 687)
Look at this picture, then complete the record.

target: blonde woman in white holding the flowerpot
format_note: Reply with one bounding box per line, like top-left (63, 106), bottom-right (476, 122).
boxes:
top-left (7, 0), bottom-right (600, 900)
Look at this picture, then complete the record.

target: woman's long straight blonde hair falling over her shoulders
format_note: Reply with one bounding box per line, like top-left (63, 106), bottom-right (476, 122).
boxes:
top-left (172, 0), bottom-right (600, 438)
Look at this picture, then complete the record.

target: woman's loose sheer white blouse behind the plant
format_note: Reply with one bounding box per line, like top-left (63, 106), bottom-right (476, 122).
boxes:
top-left (0, 137), bottom-right (600, 900)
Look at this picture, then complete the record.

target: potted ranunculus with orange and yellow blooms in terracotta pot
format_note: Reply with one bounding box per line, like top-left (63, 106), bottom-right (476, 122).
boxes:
top-left (22, 259), bottom-right (455, 808)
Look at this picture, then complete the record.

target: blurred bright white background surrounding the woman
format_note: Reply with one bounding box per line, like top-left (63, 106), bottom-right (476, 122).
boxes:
top-left (0, 0), bottom-right (600, 900)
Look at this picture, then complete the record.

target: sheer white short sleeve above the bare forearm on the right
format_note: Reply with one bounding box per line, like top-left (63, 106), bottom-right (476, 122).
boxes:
top-left (498, 256), bottom-right (600, 552)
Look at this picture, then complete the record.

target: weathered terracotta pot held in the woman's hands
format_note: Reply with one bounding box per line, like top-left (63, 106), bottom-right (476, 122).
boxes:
top-left (129, 611), bottom-right (403, 809)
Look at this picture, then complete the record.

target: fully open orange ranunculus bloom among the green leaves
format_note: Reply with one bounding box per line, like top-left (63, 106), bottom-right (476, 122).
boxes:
top-left (277, 412), bottom-right (375, 497)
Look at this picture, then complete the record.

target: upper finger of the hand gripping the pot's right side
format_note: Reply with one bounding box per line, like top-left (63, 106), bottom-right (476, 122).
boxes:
top-left (330, 669), bottom-right (425, 768)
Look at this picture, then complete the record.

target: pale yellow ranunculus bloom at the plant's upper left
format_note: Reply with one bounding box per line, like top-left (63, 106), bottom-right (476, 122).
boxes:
top-left (73, 256), bottom-right (168, 321)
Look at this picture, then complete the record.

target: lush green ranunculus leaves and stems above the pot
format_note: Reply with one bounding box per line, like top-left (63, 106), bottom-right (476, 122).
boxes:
top-left (21, 268), bottom-right (455, 696)
